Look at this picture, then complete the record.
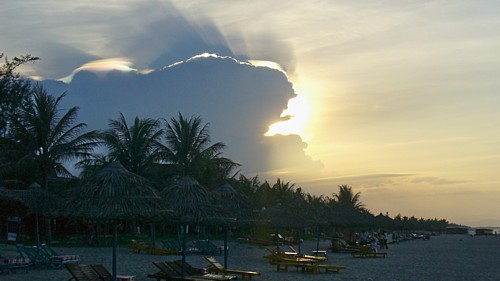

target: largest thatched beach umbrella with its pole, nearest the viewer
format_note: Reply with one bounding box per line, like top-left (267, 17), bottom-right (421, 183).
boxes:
top-left (68, 162), bottom-right (162, 281)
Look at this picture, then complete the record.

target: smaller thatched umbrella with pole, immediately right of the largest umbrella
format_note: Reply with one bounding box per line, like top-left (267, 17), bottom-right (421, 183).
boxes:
top-left (161, 176), bottom-right (219, 276)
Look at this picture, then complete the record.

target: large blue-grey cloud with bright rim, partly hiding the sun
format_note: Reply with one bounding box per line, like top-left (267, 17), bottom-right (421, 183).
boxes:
top-left (45, 54), bottom-right (318, 174)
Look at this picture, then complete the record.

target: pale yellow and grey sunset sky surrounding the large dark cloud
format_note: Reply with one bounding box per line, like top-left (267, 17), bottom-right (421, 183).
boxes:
top-left (0, 0), bottom-right (500, 226)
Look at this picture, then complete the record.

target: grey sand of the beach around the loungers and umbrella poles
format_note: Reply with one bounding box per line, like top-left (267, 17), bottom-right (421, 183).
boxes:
top-left (0, 235), bottom-right (500, 281)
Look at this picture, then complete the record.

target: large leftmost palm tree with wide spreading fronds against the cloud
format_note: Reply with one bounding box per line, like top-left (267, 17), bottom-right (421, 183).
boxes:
top-left (10, 84), bottom-right (98, 242)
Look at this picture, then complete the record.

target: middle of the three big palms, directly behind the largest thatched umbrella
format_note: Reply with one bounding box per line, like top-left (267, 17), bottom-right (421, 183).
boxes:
top-left (97, 113), bottom-right (163, 176)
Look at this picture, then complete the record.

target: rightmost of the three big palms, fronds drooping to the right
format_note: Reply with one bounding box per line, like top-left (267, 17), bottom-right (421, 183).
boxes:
top-left (164, 113), bottom-right (239, 184)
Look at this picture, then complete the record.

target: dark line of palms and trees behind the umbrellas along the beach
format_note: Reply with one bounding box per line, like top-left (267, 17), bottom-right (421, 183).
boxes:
top-left (0, 54), bottom-right (448, 241)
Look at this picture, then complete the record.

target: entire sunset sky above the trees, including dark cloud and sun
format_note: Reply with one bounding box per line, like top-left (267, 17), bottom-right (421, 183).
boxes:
top-left (0, 0), bottom-right (500, 226)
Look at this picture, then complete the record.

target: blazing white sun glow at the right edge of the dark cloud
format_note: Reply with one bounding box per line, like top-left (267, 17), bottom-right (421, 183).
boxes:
top-left (265, 94), bottom-right (310, 139)
